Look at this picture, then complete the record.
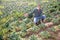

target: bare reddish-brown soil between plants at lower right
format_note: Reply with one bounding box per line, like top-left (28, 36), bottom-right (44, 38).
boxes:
top-left (25, 22), bottom-right (60, 40)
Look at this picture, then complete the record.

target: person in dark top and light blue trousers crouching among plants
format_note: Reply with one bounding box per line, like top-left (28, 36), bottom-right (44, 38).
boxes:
top-left (26, 4), bottom-right (46, 25)
